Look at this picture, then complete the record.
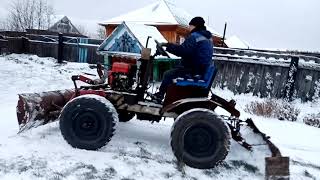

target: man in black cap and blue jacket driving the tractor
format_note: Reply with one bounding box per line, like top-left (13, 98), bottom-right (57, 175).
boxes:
top-left (152, 17), bottom-right (213, 103)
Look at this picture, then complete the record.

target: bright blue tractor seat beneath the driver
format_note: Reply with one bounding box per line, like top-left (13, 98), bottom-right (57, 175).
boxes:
top-left (174, 65), bottom-right (217, 88)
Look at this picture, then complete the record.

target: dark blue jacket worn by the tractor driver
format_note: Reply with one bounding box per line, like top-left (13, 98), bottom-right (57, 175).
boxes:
top-left (167, 30), bottom-right (213, 74)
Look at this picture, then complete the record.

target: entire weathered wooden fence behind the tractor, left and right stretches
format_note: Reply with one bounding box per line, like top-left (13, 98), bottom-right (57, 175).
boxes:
top-left (0, 30), bottom-right (320, 101)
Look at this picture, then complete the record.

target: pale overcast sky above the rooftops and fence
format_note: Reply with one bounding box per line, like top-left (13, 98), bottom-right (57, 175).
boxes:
top-left (0, 0), bottom-right (320, 51)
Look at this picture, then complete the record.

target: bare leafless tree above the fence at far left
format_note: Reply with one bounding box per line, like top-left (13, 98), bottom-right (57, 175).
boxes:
top-left (7, 0), bottom-right (54, 31)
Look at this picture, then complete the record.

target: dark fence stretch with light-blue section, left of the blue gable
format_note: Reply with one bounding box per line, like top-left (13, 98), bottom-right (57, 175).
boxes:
top-left (0, 32), bottom-right (104, 63)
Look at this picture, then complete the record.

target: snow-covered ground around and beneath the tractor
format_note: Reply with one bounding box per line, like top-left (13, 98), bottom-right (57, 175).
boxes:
top-left (0, 55), bottom-right (320, 180)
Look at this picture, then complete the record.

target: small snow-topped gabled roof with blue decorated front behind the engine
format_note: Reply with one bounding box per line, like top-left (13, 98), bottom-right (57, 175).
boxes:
top-left (98, 22), bottom-right (174, 56)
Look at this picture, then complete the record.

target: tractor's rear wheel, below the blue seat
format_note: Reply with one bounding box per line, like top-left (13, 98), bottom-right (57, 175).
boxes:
top-left (170, 108), bottom-right (231, 169)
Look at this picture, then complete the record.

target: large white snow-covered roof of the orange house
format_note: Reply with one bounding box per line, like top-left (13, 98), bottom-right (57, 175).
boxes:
top-left (100, 0), bottom-right (221, 36)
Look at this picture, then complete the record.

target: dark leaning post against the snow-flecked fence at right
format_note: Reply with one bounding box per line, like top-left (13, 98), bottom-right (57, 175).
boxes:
top-left (284, 56), bottom-right (299, 101)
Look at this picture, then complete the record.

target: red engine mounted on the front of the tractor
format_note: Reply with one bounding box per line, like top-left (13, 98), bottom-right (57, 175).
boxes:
top-left (108, 62), bottom-right (137, 92)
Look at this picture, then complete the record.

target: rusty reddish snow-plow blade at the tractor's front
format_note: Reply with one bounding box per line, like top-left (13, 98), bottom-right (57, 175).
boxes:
top-left (17, 90), bottom-right (74, 133)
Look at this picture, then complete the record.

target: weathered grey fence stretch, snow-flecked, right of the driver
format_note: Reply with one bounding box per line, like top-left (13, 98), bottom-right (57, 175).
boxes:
top-left (214, 48), bottom-right (320, 101)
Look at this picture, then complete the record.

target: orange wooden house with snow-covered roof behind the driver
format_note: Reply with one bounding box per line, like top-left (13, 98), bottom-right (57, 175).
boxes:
top-left (100, 0), bottom-right (222, 47)
